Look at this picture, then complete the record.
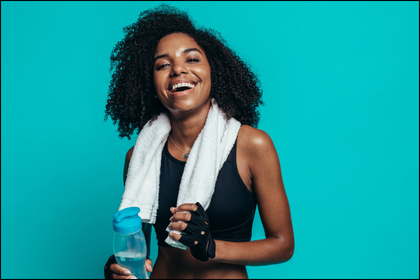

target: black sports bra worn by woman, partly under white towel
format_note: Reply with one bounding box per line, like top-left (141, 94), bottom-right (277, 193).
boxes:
top-left (153, 137), bottom-right (256, 247)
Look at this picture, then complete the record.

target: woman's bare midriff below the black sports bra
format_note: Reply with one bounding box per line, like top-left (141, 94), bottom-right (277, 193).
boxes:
top-left (150, 247), bottom-right (248, 279)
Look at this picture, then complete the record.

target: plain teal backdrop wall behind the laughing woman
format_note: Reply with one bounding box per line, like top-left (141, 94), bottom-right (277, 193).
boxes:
top-left (1, 1), bottom-right (419, 278)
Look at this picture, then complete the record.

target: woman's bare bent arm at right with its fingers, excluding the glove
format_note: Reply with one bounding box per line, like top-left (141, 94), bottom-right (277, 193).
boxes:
top-left (169, 126), bottom-right (294, 265)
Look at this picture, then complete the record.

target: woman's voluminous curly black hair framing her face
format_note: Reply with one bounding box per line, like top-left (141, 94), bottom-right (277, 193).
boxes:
top-left (105, 4), bottom-right (263, 139)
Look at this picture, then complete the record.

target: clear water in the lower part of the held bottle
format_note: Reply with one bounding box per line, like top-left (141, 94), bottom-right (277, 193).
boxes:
top-left (115, 252), bottom-right (149, 279)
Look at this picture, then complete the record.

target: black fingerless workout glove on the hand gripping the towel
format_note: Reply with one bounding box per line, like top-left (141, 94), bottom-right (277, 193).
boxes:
top-left (179, 202), bottom-right (216, 262)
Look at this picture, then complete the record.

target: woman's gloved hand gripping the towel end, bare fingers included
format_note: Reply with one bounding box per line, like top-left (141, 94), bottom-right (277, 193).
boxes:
top-left (169, 202), bottom-right (216, 261)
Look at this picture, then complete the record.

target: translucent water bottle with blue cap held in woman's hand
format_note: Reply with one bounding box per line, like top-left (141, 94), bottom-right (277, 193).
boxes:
top-left (112, 207), bottom-right (149, 279)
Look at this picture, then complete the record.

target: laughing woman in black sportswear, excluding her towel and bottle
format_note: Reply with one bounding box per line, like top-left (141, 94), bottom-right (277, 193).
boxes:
top-left (105, 5), bottom-right (294, 279)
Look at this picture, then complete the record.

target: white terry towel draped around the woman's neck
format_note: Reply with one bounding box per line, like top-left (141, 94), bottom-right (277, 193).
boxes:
top-left (119, 99), bottom-right (241, 250)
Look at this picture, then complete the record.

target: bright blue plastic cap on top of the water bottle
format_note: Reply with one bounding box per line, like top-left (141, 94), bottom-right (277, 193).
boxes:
top-left (112, 207), bottom-right (141, 233)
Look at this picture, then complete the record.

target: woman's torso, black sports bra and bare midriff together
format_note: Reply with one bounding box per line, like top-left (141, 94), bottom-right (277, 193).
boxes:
top-left (151, 128), bottom-right (256, 278)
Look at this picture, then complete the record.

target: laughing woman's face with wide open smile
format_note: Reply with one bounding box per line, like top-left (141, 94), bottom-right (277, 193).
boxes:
top-left (153, 33), bottom-right (211, 115)
